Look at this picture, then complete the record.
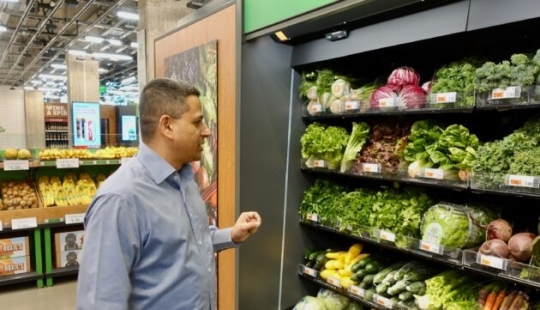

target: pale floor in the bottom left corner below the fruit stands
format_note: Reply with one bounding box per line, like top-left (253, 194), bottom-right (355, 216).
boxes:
top-left (0, 278), bottom-right (77, 310)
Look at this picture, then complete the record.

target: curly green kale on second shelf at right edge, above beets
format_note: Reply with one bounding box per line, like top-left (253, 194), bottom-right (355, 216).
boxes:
top-left (472, 118), bottom-right (540, 189)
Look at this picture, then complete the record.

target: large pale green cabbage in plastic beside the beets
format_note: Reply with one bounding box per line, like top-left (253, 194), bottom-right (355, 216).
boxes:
top-left (420, 203), bottom-right (497, 249)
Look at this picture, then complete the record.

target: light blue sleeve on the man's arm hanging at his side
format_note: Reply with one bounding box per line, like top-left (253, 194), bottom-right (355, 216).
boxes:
top-left (77, 194), bottom-right (141, 310)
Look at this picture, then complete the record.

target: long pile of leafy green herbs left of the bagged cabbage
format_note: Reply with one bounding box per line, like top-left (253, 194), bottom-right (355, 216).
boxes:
top-left (300, 179), bottom-right (432, 247)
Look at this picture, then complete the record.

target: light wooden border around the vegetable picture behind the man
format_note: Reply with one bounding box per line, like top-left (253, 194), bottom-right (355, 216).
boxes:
top-left (154, 5), bottom-right (239, 310)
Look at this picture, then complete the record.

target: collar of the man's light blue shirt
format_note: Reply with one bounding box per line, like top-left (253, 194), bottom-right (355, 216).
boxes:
top-left (137, 142), bottom-right (193, 184)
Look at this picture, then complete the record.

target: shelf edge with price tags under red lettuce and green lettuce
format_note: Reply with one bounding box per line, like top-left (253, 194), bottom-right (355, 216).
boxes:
top-left (301, 165), bottom-right (469, 190)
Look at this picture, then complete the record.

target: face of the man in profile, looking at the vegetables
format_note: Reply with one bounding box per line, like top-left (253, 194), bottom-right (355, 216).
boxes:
top-left (172, 96), bottom-right (210, 163)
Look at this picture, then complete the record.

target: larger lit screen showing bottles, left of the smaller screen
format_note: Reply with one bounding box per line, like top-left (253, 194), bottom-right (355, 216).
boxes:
top-left (71, 101), bottom-right (101, 148)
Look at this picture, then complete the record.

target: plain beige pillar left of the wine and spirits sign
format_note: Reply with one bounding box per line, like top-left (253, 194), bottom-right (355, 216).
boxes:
top-left (24, 91), bottom-right (45, 149)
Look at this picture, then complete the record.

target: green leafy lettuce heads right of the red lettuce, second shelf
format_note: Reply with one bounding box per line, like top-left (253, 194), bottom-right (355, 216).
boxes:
top-left (403, 120), bottom-right (480, 177)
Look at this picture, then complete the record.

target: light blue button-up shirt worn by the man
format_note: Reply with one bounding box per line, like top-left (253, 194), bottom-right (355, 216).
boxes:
top-left (77, 143), bottom-right (236, 310)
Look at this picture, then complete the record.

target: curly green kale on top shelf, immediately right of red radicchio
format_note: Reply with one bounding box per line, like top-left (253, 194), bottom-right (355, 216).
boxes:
top-left (430, 60), bottom-right (476, 107)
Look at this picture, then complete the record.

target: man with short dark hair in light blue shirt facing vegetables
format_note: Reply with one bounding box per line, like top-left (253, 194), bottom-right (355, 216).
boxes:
top-left (77, 79), bottom-right (261, 310)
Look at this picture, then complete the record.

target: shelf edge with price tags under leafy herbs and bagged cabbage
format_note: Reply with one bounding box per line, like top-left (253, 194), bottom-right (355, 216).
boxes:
top-left (300, 220), bottom-right (463, 268)
